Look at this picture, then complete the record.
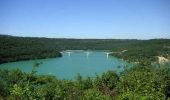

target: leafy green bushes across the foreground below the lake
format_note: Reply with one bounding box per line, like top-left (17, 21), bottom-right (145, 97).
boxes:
top-left (0, 63), bottom-right (170, 100)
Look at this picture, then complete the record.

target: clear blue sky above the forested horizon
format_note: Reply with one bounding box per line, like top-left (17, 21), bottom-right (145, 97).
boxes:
top-left (0, 0), bottom-right (170, 39)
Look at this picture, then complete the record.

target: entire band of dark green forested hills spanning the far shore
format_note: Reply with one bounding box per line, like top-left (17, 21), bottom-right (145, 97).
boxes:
top-left (0, 35), bottom-right (170, 63)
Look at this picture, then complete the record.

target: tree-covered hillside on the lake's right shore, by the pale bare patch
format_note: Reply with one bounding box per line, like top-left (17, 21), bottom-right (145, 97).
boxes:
top-left (111, 39), bottom-right (170, 62)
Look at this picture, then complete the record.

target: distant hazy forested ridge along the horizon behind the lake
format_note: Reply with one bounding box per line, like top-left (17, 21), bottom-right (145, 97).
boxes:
top-left (0, 35), bottom-right (142, 50)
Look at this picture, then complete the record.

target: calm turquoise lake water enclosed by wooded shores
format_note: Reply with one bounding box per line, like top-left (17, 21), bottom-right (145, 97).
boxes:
top-left (0, 51), bottom-right (126, 79)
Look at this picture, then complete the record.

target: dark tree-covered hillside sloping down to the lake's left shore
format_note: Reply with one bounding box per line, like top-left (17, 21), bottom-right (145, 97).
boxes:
top-left (0, 35), bottom-right (61, 64)
